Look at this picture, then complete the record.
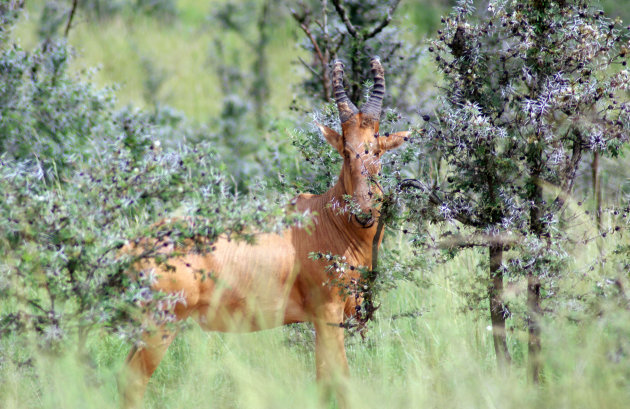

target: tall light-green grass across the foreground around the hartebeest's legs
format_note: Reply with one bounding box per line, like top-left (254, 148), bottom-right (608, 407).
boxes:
top-left (0, 233), bottom-right (630, 409)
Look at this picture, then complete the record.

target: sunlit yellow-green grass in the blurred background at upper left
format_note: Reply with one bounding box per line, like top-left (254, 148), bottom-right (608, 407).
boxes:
top-left (16, 1), bottom-right (299, 122)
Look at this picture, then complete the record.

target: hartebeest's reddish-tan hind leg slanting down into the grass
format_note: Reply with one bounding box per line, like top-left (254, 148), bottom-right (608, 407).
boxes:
top-left (118, 329), bottom-right (176, 409)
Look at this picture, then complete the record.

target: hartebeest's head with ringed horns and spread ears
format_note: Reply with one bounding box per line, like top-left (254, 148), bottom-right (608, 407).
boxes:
top-left (318, 57), bottom-right (409, 228)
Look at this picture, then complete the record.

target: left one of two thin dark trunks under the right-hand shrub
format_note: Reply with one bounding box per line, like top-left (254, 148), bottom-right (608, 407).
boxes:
top-left (488, 245), bottom-right (512, 369)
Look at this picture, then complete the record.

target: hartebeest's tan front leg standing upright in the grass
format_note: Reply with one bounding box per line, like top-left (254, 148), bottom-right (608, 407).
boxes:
top-left (314, 303), bottom-right (350, 408)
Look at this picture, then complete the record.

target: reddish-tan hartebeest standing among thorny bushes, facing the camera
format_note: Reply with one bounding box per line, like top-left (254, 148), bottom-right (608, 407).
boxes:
top-left (121, 57), bottom-right (409, 407)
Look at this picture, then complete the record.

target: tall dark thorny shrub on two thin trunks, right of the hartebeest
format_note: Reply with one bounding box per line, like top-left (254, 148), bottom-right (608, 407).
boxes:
top-left (414, 0), bottom-right (630, 380)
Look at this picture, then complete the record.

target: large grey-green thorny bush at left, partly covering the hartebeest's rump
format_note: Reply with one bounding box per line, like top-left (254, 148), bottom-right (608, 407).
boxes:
top-left (0, 10), bottom-right (307, 359)
